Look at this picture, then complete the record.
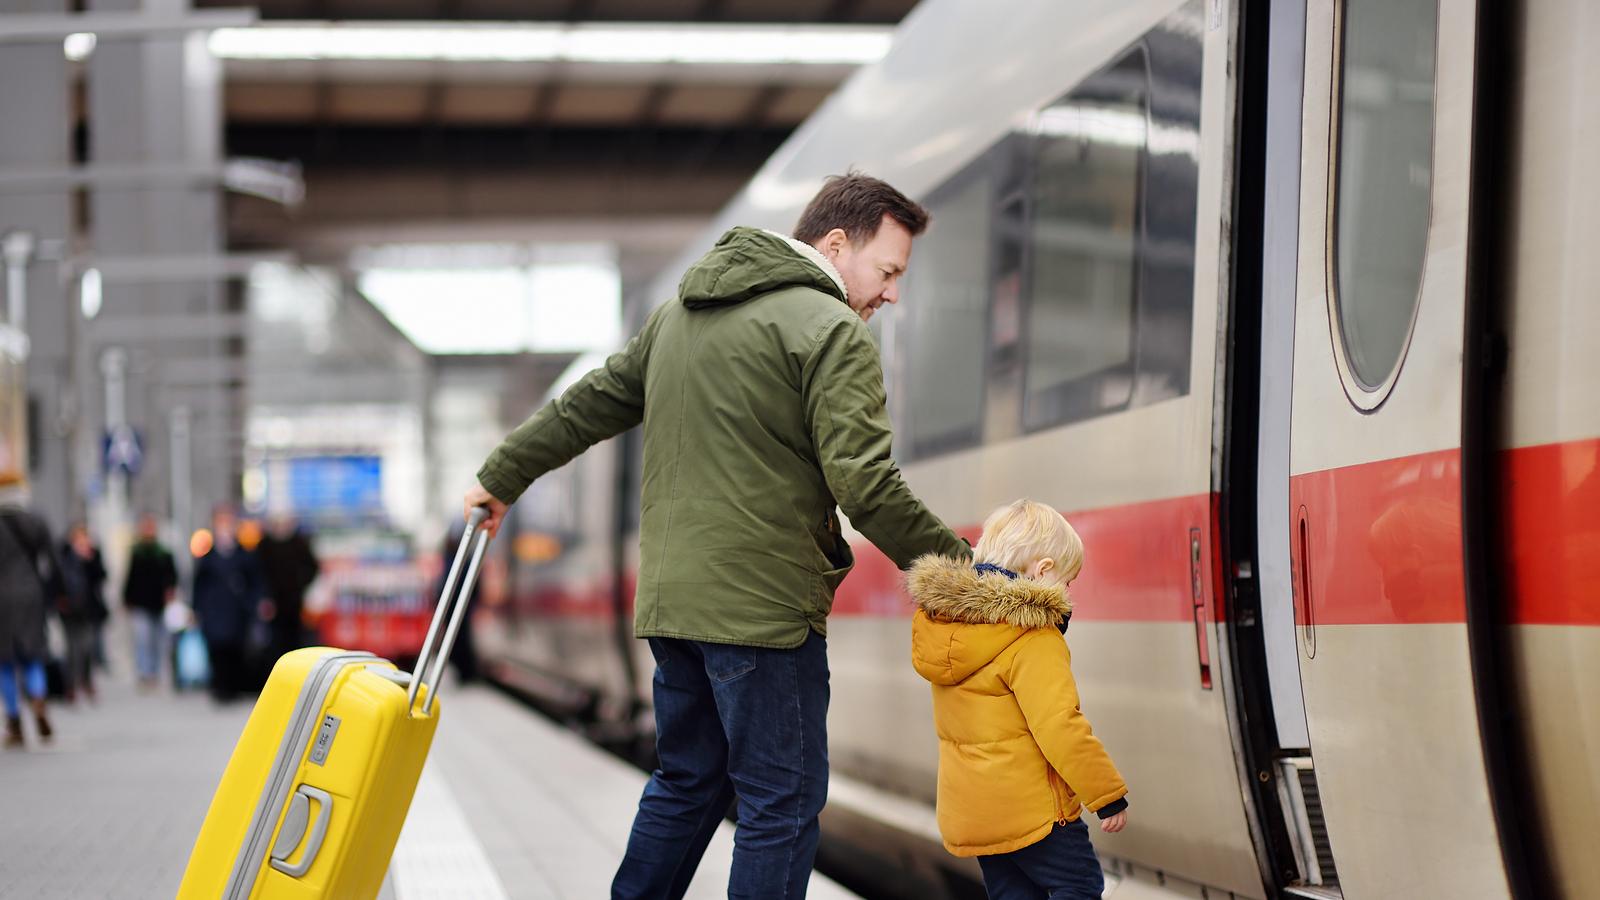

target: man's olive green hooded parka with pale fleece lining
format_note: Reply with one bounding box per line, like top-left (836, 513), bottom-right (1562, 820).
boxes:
top-left (478, 227), bottom-right (970, 647)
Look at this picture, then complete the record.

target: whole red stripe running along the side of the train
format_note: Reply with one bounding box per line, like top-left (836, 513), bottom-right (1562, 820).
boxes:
top-left (505, 439), bottom-right (1600, 625)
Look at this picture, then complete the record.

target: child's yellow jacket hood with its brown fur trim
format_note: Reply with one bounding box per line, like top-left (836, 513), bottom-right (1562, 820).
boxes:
top-left (906, 556), bottom-right (1072, 685)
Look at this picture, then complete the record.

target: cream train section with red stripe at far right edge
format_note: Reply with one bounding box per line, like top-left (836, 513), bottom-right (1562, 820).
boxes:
top-left (1491, 2), bottom-right (1600, 898)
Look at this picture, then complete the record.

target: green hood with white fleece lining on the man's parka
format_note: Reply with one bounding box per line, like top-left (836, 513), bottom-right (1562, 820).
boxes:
top-left (678, 226), bottom-right (845, 309)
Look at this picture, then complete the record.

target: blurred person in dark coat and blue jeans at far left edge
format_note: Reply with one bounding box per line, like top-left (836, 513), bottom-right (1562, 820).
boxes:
top-left (0, 493), bottom-right (61, 748)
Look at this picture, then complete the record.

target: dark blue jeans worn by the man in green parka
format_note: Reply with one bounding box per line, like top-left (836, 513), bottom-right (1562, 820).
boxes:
top-left (611, 633), bottom-right (829, 900)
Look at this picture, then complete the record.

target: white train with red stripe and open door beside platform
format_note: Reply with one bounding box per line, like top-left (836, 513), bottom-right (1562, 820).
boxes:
top-left (478, 0), bottom-right (1600, 900)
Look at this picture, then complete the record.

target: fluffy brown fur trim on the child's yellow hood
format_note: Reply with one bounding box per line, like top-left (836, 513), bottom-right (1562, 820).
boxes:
top-left (906, 554), bottom-right (1072, 628)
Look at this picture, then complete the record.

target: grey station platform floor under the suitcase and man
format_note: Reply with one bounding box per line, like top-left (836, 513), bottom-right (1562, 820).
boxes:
top-left (0, 669), bottom-right (854, 900)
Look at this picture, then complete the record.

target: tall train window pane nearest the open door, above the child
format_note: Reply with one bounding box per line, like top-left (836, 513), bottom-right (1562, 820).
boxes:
top-left (1022, 46), bottom-right (1150, 429)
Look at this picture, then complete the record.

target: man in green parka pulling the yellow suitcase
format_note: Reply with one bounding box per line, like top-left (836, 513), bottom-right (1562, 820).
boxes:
top-left (466, 173), bottom-right (970, 900)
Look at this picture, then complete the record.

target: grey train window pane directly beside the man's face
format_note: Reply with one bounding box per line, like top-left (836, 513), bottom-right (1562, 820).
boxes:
top-left (896, 167), bottom-right (992, 456)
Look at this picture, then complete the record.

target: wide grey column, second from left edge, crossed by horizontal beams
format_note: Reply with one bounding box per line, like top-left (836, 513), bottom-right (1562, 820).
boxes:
top-left (85, 0), bottom-right (242, 527)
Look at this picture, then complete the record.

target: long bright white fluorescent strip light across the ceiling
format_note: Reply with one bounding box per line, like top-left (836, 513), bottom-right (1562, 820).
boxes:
top-left (211, 22), bottom-right (893, 66)
